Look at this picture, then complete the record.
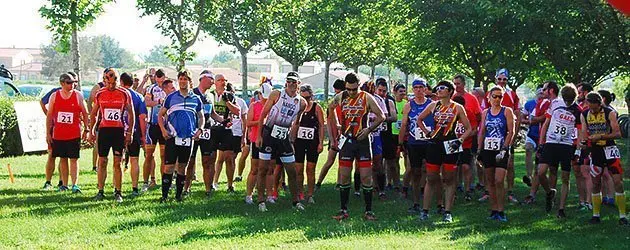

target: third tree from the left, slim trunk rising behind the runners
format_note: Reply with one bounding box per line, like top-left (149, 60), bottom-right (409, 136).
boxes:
top-left (203, 0), bottom-right (266, 99)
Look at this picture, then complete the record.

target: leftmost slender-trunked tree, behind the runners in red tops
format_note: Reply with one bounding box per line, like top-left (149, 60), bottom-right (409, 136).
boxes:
top-left (39, 0), bottom-right (111, 90)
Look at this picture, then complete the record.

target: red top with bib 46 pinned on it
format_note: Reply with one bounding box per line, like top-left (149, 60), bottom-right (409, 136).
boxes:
top-left (95, 87), bottom-right (130, 128)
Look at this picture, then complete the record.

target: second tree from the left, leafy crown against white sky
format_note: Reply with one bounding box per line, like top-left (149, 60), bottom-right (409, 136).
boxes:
top-left (137, 0), bottom-right (210, 70)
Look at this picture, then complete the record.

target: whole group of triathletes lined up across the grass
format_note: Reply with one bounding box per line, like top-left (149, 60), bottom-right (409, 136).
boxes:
top-left (41, 68), bottom-right (628, 225)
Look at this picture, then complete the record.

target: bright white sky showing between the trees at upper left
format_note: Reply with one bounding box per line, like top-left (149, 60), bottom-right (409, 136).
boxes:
top-left (0, 0), bottom-right (225, 57)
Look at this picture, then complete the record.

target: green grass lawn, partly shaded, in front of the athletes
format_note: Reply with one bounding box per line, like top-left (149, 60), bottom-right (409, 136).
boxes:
top-left (0, 145), bottom-right (630, 249)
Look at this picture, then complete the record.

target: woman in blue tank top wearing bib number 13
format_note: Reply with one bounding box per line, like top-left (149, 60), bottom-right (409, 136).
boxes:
top-left (477, 86), bottom-right (515, 222)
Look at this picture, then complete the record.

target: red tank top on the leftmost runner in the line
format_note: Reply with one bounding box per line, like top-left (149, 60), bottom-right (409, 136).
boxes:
top-left (52, 89), bottom-right (81, 141)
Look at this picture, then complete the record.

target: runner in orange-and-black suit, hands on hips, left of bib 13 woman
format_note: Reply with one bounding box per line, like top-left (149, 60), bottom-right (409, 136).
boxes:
top-left (418, 81), bottom-right (473, 222)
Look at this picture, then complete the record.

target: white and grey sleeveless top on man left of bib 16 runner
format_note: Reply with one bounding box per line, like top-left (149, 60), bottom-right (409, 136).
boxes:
top-left (265, 91), bottom-right (300, 128)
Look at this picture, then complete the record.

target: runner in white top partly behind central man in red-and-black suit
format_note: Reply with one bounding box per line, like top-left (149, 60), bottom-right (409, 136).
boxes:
top-left (362, 80), bottom-right (388, 200)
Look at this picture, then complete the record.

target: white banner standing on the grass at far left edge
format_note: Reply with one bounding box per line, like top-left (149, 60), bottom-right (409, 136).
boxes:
top-left (13, 101), bottom-right (48, 153)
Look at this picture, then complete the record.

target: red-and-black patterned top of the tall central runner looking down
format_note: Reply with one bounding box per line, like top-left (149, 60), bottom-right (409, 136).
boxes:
top-left (341, 91), bottom-right (368, 137)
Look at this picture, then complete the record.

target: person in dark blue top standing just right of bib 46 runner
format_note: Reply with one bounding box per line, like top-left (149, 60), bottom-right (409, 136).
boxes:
top-left (120, 73), bottom-right (147, 197)
